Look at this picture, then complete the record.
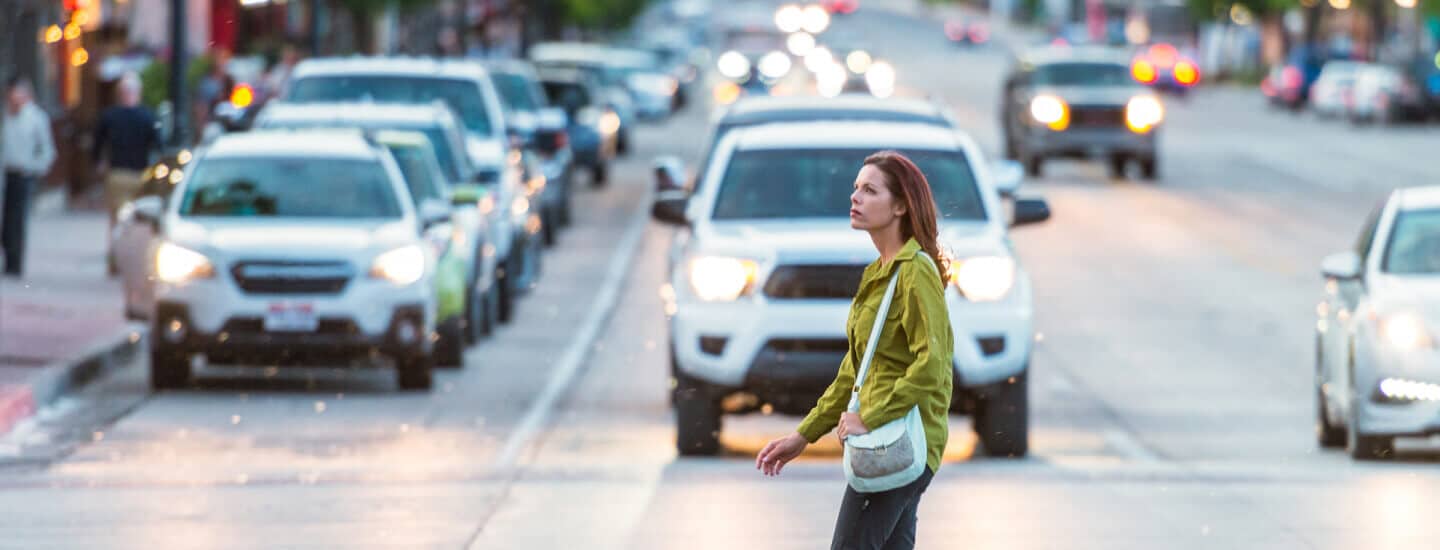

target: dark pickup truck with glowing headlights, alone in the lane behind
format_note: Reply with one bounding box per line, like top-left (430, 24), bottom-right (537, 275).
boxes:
top-left (1001, 48), bottom-right (1165, 180)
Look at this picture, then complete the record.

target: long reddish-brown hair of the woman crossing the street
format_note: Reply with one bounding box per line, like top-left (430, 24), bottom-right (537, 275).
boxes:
top-left (865, 151), bottom-right (950, 285)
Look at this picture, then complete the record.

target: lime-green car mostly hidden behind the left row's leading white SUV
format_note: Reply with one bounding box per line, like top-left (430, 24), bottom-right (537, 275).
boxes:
top-left (374, 131), bottom-right (495, 367)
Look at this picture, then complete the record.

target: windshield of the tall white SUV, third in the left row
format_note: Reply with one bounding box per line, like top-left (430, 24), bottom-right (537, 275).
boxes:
top-left (285, 75), bottom-right (495, 135)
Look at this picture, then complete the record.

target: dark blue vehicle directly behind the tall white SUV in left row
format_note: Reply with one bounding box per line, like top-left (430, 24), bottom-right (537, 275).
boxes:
top-left (485, 62), bottom-right (575, 231)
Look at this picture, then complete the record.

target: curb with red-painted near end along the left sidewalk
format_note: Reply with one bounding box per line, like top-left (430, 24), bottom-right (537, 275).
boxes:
top-left (0, 325), bottom-right (145, 435)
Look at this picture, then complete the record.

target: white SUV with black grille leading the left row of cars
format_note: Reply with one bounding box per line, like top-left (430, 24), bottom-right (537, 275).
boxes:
top-left (121, 131), bottom-right (449, 389)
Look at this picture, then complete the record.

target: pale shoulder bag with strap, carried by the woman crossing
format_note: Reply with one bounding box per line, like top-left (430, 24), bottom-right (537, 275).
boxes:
top-left (844, 253), bottom-right (933, 492)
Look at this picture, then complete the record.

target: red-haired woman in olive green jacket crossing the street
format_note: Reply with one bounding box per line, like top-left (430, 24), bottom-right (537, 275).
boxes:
top-left (756, 151), bottom-right (955, 550)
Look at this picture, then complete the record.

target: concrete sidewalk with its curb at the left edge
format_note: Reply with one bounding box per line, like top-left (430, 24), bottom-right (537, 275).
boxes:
top-left (0, 191), bottom-right (143, 433)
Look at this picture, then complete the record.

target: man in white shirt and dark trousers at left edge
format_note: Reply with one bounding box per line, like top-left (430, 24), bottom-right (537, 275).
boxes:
top-left (0, 76), bottom-right (55, 278)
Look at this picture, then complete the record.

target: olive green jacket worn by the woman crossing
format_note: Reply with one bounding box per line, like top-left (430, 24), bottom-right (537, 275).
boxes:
top-left (798, 239), bottom-right (955, 472)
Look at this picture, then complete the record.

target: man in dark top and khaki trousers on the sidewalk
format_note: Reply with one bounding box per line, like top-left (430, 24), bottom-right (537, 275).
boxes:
top-left (95, 73), bottom-right (160, 229)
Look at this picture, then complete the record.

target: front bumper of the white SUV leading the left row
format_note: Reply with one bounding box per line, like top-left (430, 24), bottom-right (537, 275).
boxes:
top-left (153, 276), bottom-right (436, 361)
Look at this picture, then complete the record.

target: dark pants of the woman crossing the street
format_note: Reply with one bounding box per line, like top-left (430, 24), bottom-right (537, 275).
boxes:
top-left (829, 466), bottom-right (935, 550)
